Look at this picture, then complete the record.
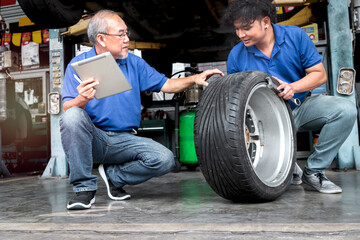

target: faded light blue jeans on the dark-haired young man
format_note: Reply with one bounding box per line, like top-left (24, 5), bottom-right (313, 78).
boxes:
top-left (293, 95), bottom-right (357, 174)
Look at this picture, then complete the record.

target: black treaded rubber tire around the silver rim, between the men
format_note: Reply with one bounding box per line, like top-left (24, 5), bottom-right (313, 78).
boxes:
top-left (194, 71), bottom-right (296, 202)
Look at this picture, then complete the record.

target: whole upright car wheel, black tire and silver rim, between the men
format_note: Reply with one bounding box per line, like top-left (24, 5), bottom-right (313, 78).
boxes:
top-left (194, 71), bottom-right (296, 202)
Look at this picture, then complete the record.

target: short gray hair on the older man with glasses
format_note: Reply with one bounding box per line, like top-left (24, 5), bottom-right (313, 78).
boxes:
top-left (87, 10), bottom-right (118, 44)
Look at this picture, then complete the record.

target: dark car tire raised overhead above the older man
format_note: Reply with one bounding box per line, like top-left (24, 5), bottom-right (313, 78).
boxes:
top-left (18, 0), bottom-right (84, 29)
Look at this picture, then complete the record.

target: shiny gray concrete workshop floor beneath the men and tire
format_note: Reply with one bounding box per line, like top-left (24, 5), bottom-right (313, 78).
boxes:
top-left (0, 160), bottom-right (360, 240)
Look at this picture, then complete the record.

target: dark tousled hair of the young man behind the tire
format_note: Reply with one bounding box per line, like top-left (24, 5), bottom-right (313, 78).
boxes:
top-left (222, 0), bottom-right (276, 26)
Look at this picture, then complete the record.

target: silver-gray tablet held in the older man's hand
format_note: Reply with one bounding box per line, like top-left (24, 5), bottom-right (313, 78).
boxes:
top-left (71, 52), bottom-right (132, 99)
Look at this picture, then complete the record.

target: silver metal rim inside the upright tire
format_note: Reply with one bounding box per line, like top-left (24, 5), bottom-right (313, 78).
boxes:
top-left (244, 83), bottom-right (294, 187)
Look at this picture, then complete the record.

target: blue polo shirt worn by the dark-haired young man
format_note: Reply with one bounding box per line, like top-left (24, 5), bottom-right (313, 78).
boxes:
top-left (227, 24), bottom-right (321, 107)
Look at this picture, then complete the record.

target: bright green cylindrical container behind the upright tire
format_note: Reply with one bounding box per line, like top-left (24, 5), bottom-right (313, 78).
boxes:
top-left (179, 110), bottom-right (198, 164)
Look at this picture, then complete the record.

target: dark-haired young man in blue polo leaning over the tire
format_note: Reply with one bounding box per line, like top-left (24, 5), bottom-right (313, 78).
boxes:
top-left (223, 0), bottom-right (356, 193)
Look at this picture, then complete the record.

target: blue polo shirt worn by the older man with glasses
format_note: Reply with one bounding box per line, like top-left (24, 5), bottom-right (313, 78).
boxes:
top-left (62, 48), bottom-right (167, 131)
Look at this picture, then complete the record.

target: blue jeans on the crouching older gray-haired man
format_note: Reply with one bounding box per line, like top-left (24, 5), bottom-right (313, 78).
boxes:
top-left (60, 108), bottom-right (175, 192)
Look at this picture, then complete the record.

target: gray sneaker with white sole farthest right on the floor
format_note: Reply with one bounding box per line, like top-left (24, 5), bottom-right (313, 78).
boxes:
top-left (302, 172), bottom-right (342, 193)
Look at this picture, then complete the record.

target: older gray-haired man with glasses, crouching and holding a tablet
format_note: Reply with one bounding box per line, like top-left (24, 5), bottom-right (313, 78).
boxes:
top-left (60, 10), bottom-right (223, 210)
